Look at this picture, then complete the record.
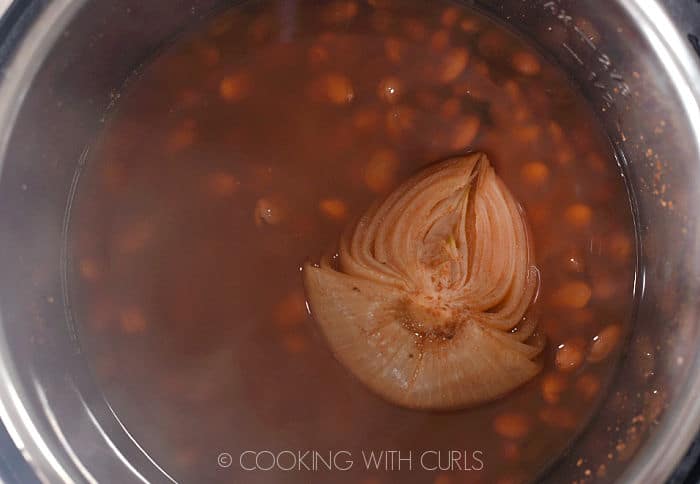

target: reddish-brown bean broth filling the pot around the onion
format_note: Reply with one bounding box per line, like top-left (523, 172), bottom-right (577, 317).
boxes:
top-left (70, 0), bottom-right (634, 484)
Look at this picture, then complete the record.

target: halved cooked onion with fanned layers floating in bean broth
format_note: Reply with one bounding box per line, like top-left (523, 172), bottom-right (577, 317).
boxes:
top-left (304, 153), bottom-right (544, 410)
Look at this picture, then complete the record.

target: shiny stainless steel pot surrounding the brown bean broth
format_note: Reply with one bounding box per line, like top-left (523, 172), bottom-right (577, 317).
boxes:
top-left (0, 0), bottom-right (700, 483)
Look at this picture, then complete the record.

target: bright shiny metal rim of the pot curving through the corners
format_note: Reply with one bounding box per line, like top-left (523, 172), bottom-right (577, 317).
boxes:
top-left (0, 0), bottom-right (700, 483)
